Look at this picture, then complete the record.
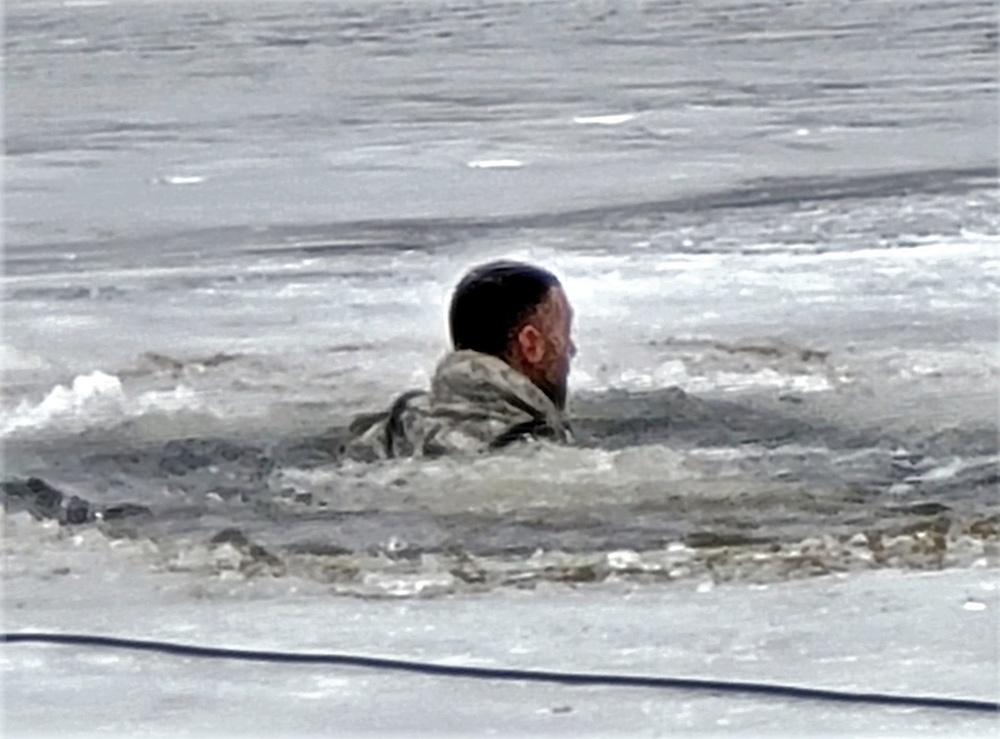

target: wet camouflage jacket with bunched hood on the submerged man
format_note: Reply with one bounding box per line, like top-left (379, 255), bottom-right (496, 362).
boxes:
top-left (345, 351), bottom-right (570, 461)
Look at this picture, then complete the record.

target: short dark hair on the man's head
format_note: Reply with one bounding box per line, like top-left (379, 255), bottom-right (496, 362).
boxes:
top-left (448, 261), bottom-right (559, 357)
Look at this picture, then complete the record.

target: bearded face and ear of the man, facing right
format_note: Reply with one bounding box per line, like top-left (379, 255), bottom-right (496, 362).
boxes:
top-left (518, 287), bottom-right (576, 409)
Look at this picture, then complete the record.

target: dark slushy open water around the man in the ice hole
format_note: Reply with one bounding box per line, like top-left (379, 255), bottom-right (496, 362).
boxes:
top-left (6, 368), bottom-right (1000, 592)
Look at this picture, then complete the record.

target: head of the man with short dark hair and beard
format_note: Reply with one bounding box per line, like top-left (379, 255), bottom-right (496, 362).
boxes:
top-left (449, 261), bottom-right (576, 408)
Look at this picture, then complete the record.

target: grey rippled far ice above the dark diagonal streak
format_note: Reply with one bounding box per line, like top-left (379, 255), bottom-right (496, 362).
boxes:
top-left (5, 0), bottom-right (996, 244)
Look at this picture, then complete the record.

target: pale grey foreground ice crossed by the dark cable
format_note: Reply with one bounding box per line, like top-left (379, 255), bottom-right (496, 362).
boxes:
top-left (0, 516), bottom-right (1000, 736)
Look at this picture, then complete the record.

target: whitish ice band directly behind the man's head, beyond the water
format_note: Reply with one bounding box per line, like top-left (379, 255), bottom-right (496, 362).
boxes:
top-left (3, 184), bottom-right (1000, 422)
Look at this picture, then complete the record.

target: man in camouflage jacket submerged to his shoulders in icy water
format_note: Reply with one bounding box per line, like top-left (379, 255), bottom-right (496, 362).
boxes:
top-left (346, 261), bottom-right (576, 460)
